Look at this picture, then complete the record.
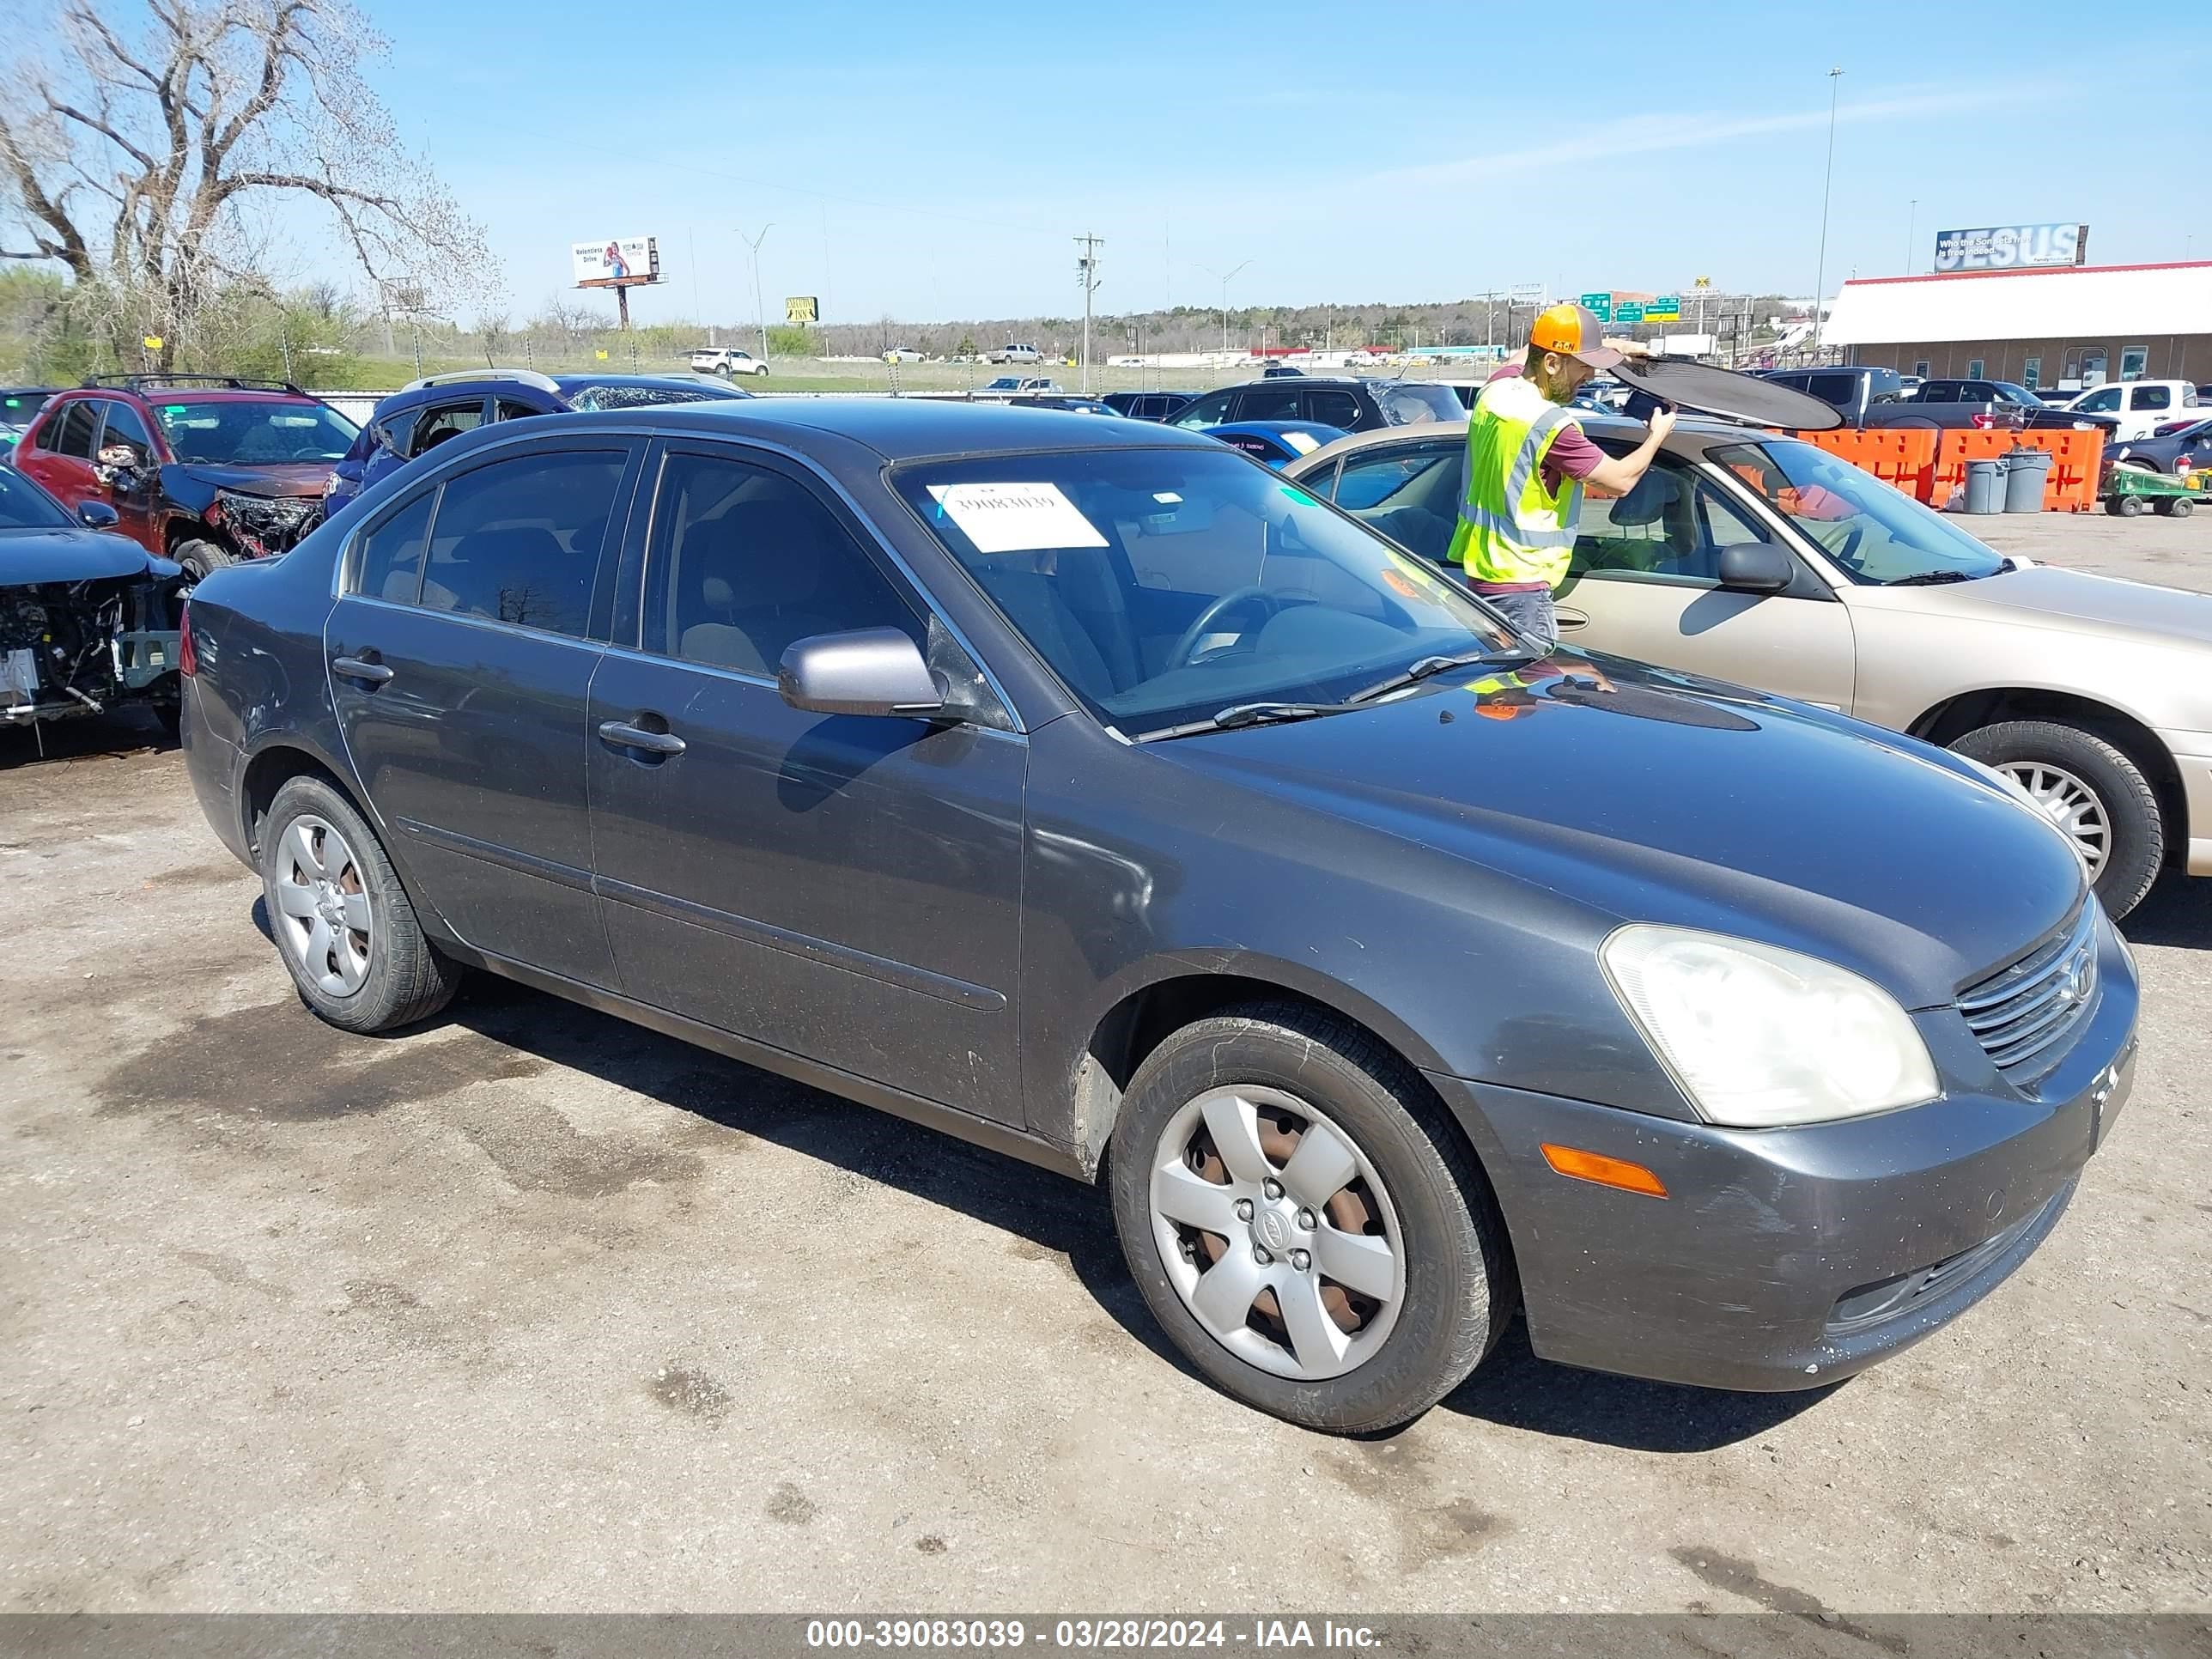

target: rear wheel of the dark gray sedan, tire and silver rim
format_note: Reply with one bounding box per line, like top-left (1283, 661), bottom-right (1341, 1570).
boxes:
top-left (257, 776), bottom-right (460, 1033)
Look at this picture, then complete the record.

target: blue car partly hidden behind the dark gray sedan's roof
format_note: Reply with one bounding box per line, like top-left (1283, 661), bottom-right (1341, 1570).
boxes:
top-left (323, 369), bottom-right (752, 518)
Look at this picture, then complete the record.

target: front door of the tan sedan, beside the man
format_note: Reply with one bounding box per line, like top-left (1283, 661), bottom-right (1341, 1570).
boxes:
top-left (1558, 456), bottom-right (1856, 710)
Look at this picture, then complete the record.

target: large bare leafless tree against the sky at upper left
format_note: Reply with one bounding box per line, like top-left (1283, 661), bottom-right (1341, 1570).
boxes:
top-left (0, 0), bottom-right (495, 368)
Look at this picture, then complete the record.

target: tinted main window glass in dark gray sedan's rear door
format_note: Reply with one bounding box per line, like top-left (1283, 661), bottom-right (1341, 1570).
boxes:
top-left (420, 449), bottom-right (626, 639)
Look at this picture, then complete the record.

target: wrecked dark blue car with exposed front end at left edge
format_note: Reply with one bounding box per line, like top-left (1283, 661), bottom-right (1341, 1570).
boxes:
top-left (0, 467), bottom-right (184, 730)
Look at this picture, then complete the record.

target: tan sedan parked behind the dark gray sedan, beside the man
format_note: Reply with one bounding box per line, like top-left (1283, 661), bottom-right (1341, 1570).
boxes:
top-left (1285, 414), bottom-right (2212, 915)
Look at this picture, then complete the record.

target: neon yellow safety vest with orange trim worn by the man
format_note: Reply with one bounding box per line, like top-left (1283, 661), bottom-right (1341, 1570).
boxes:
top-left (1444, 374), bottom-right (1582, 586)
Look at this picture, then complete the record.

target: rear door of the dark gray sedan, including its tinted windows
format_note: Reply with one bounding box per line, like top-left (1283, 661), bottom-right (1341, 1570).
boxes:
top-left (323, 434), bottom-right (644, 988)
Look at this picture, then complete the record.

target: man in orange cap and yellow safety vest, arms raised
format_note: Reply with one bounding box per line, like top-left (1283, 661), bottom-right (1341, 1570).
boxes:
top-left (1444, 305), bottom-right (1674, 650)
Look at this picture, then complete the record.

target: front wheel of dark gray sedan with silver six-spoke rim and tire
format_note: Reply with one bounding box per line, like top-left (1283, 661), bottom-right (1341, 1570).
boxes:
top-left (1109, 1005), bottom-right (1516, 1433)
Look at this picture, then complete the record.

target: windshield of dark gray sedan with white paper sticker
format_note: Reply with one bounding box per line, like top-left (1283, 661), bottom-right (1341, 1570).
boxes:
top-left (894, 449), bottom-right (1520, 737)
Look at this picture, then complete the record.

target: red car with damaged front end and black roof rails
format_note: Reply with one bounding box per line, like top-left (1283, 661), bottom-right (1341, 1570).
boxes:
top-left (13, 374), bottom-right (358, 581)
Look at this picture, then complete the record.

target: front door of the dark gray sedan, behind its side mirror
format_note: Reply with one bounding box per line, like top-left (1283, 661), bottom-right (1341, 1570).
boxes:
top-left (588, 442), bottom-right (1029, 1124)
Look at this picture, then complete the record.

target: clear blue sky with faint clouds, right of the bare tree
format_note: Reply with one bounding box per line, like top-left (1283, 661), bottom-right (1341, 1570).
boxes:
top-left (251, 0), bottom-right (2212, 321)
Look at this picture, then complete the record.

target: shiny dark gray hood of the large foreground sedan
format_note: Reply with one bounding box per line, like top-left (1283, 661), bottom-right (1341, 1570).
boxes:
top-left (1155, 659), bottom-right (2084, 1009)
